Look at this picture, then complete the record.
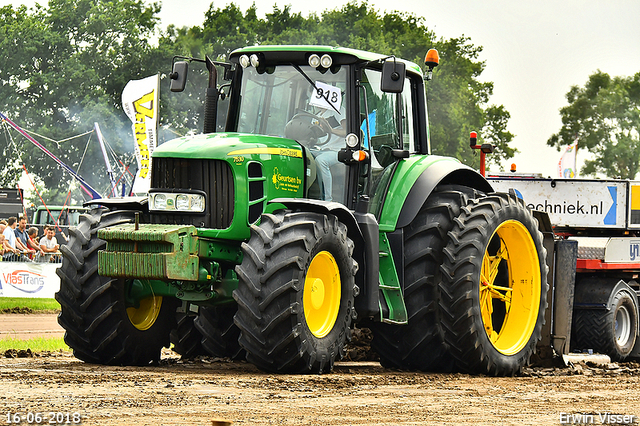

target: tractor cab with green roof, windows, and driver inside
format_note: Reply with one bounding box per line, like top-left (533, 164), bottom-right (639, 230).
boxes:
top-left (173, 46), bottom-right (429, 215)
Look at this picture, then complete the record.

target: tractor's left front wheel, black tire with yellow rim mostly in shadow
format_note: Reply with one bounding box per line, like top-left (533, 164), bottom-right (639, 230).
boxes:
top-left (55, 209), bottom-right (177, 365)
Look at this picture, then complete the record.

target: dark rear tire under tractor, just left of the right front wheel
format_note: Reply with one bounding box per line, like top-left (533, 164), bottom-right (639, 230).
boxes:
top-left (194, 304), bottom-right (246, 360)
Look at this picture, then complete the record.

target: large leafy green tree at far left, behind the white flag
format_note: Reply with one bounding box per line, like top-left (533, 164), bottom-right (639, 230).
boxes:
top-left (0, 0), bottom-right (160, 202)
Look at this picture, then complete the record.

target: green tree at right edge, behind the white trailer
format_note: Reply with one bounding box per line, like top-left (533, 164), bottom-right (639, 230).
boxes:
top-left (547, 70), bottom-right (640, 179)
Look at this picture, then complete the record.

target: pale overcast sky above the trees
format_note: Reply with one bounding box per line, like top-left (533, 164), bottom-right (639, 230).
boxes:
top-left (0, 0), bottom-right (640, 177)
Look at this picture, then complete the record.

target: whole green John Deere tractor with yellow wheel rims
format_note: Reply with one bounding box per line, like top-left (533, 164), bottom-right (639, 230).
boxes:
top-left (56, 46), bottom-right (548, 375)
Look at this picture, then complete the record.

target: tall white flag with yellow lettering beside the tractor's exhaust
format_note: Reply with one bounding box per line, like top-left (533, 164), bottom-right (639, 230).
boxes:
top-left (122, 74), bottom-right (160, 194)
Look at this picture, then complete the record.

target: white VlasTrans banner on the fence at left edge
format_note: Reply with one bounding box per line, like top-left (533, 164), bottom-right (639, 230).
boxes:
top-left (0, 261), bottom-right (60, 299)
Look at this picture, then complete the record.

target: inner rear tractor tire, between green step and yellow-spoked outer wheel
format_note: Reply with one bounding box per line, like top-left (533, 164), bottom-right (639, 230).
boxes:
top-left (371, 185), bottom-right (473, 372)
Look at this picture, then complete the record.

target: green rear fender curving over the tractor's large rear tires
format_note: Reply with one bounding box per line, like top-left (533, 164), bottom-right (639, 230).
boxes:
top-left (380, 155), bottom-right (493, 232)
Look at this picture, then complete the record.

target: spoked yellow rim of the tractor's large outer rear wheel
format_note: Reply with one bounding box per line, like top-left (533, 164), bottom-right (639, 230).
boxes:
top-left (480, 220), bottom-right (541, 355)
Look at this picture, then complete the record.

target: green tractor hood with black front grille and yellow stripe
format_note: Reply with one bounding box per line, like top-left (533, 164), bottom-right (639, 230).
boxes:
top-left (151, 133), bottom-right (314, 240)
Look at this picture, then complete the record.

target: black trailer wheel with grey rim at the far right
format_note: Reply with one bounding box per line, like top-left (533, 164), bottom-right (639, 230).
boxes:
top-left (571, 290), bottom-right (638, 361)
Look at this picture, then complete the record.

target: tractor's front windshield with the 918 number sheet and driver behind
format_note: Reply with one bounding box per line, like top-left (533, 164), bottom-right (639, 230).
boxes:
top-left (237, 65), bottom-right (348, 202)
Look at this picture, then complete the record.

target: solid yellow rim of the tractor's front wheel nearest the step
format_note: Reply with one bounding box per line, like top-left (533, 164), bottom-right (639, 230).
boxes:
top-left (302, 251), bottom-right (342, 339)
